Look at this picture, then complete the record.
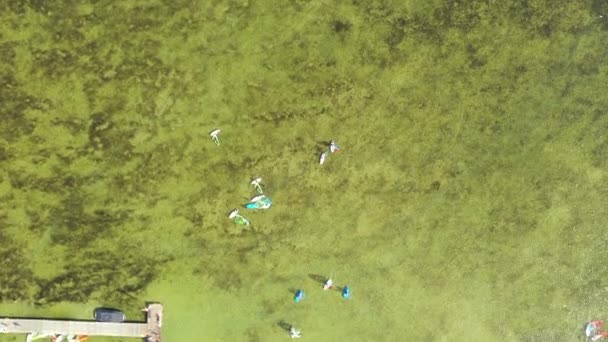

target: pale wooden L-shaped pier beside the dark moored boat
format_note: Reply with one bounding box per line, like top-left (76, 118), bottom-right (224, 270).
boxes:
top-left (0, 304), bottom-right (163, 342)
